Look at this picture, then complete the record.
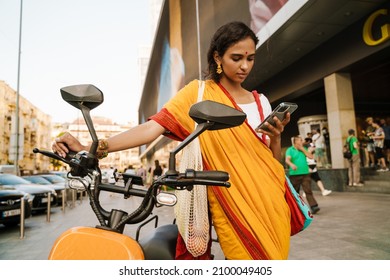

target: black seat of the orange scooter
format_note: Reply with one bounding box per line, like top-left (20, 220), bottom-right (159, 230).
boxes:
top-left (139, 224), bottom-right (178, 260)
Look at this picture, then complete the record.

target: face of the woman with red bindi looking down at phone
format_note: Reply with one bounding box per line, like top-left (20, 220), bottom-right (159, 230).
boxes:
top-left (220, 37), bottom-right (256, 84)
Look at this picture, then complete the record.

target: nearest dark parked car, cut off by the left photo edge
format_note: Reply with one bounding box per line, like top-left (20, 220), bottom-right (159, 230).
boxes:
top-left (0, 186), bottom-right (33, 226)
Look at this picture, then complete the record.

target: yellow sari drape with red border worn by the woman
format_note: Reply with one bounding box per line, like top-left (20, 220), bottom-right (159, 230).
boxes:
top-left (151, 80), bottom-right (290, 260)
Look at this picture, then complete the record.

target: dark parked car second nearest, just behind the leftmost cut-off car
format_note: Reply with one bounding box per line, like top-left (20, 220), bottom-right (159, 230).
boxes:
top-left (0, 174), bottom-right (57, 212)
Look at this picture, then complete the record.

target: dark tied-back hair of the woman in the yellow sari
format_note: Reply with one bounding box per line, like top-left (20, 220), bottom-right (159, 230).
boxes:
top-left (206, 21), bottom-right (259, 83)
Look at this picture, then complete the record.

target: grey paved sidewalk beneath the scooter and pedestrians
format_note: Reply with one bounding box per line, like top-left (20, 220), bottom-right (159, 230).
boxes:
top-left (0, 189), bottom-right (390, 260)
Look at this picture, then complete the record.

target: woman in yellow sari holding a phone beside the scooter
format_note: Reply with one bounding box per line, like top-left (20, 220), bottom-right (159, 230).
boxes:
top-left (52, 22), bottom-right (290, 259)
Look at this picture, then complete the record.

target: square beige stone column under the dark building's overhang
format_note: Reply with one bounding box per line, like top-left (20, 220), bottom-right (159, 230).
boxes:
top-left (324, 73), bottom-right (356, 168)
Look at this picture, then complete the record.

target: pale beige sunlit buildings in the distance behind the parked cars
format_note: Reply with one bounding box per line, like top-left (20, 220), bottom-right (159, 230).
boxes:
top-left (0, 81), bottom-right (140, 174)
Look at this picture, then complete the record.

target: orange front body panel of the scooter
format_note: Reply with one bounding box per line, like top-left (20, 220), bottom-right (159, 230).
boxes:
top-left (49, 227), bottom-right (144, 260)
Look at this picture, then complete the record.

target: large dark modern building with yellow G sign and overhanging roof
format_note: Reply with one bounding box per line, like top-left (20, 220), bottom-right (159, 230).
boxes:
top-left (139, 0), bottom-right (390, 168)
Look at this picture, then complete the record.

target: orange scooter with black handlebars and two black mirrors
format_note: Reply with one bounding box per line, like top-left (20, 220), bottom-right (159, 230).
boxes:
top-left (33, 84), bottom-right (246, 260)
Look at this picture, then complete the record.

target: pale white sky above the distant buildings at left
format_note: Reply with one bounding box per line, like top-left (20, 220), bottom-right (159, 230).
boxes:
top-left (0, 0), bottom-right (158, 124)
